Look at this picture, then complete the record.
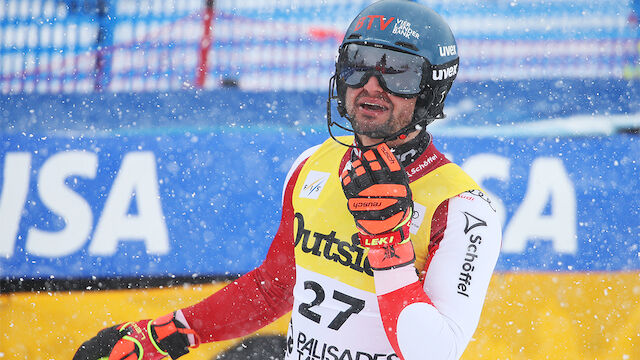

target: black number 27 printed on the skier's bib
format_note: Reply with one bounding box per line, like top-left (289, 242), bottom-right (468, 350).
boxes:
top-left (298, 281), bottom-right (364, 330)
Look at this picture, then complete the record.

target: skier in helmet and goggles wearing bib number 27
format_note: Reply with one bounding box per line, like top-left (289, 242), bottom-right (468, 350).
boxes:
top-left (74, 0), bottom-right (501, 360)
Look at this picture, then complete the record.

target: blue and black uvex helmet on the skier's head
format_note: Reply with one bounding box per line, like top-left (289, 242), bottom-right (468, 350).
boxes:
top-left (327, 0), bottom-right (459, 146)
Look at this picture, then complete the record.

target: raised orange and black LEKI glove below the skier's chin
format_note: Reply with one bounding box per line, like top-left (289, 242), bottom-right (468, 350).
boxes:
top-left (341, 143), bottom-right (415, 270)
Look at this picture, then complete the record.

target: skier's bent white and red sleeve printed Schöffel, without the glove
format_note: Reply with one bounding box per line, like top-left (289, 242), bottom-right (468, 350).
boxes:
top-left (374, 193), bottom-right (502, 360)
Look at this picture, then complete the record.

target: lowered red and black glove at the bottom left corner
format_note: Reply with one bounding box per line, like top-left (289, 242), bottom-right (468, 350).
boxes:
top-left (73, 313), bottom-right (200, 360)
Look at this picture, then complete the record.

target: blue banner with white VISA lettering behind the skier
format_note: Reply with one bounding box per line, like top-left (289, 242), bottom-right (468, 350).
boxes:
top-left (0, 127), bottom-right (640, 279)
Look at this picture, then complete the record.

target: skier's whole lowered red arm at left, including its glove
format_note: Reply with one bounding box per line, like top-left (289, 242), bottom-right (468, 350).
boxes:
top-left (73, 147), bottom-right (317, 360)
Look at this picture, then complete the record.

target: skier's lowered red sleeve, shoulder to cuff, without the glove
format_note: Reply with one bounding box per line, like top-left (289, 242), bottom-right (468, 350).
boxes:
top-left (177, 147), bottom-right (317, 342)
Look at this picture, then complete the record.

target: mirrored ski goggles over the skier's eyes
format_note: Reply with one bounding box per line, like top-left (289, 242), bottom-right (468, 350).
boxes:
top-left (336, 44), bottom-right (428, 97)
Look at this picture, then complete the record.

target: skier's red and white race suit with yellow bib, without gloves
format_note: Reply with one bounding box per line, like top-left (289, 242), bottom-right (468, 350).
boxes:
top-left (177, 134), bottom-right (501, 360)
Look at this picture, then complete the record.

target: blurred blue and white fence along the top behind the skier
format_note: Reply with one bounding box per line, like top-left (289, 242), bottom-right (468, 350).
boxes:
top-left (0, 0), bottom-right (640, 94)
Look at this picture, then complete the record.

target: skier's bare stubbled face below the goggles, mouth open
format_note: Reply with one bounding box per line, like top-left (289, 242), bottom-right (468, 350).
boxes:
top-left (345, 76), bottom-right (417, 145)
